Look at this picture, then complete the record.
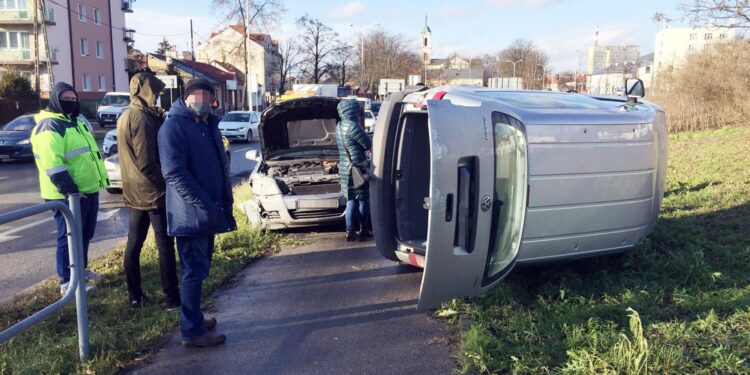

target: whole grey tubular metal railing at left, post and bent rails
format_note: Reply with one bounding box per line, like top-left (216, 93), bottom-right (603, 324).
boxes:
top-left (0, 194), bottom-right (89, 361)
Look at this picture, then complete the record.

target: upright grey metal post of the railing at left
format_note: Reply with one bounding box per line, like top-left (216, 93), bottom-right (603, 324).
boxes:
top-left (68, 194), bottom-right (89, 361)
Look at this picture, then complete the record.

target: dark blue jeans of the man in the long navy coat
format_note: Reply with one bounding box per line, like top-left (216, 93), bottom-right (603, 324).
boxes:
top-left (176, 236), bottom-right (214, 340)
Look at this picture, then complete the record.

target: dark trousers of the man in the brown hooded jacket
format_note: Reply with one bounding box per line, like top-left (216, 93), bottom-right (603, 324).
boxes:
top-left (124, 208), bottom-right (180, 305)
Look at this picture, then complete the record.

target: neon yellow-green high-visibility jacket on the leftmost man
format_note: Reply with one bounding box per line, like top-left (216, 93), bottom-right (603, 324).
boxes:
top-left (31, 111), bottom-right (109, 199)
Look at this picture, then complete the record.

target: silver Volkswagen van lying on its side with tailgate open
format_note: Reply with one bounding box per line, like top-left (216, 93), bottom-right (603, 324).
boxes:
top-left (371, 80), bottom-right (667, 309)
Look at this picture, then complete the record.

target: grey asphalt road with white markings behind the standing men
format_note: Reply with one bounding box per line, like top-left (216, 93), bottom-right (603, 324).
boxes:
top-left (0, 126), bottom-right (259, 305)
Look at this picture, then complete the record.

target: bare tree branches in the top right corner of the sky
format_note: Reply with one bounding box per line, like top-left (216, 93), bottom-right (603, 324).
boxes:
top-left (679, 0), bottom-right (750, 29)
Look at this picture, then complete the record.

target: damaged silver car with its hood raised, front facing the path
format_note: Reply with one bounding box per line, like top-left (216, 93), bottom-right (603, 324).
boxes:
top-left (242, 97), bottom-right (345, 229)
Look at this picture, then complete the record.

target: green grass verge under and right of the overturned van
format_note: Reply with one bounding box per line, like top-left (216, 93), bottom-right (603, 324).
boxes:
top-left (446, 128), bottom-right (750, 374)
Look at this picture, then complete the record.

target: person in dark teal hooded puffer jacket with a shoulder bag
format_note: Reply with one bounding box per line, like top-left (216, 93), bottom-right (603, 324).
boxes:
top-left (336, 99), bottom-right (372, 241)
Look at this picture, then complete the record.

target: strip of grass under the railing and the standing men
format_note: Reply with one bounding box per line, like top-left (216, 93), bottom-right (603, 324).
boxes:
top-left (0, 186), bottom-right (278, 374)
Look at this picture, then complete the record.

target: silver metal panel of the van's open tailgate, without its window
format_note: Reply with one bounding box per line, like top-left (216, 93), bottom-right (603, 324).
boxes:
top-left (418, 100), bottom-right (506, 309)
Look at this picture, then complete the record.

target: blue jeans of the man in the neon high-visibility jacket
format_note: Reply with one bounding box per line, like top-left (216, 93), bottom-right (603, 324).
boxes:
top-left (55, 193), bottom-right (99, 284)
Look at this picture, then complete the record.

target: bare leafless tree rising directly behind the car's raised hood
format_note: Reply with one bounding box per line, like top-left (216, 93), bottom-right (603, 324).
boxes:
top-left (297, 15), bottom-right (342, 83)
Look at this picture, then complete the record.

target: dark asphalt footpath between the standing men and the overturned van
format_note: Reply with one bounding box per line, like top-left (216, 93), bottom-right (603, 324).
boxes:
top-left (131, 233), bottom-right (455, 374)
